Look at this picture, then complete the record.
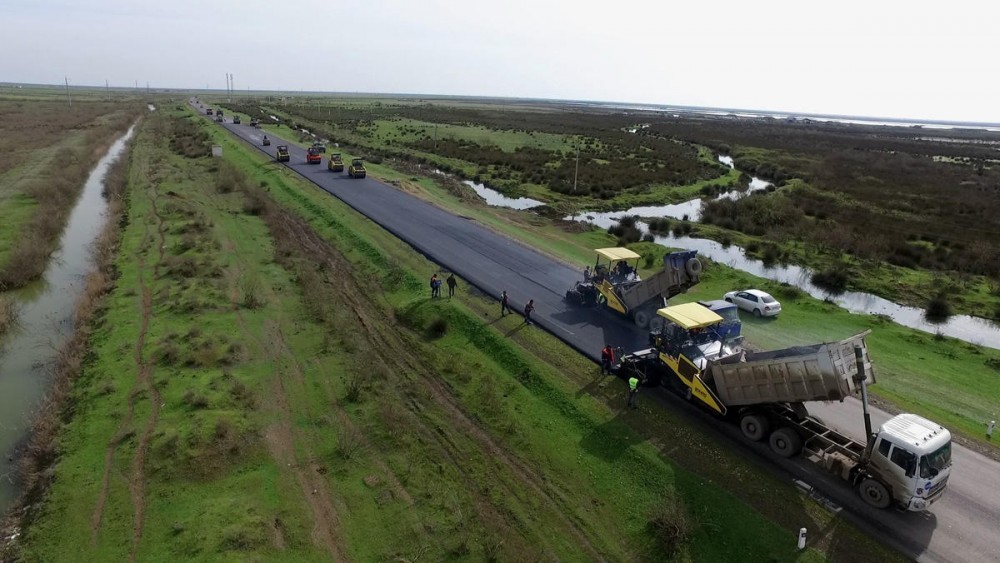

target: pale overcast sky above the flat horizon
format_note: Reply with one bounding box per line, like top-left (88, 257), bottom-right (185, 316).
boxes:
top-left (7, 0), bottom-right (1000, 122)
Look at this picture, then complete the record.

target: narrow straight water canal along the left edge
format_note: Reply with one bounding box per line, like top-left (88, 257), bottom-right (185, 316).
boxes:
top-left (0, 125), bottom-right (135, 512)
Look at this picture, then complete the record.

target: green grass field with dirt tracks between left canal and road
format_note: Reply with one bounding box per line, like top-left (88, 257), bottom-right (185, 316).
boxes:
top-left (5, 108), bottom-right (908, 561)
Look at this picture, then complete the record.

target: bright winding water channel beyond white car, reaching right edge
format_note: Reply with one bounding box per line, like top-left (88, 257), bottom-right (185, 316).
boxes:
top-left (566, 211), bottom-right (1000, 349)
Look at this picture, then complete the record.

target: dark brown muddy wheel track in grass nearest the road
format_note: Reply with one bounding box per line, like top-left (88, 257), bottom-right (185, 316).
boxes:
top-left (273, 205), bottom-right (604, 560)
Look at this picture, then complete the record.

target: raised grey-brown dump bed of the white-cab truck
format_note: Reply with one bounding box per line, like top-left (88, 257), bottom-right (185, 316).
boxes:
top-left (706, 331), bottom-right (875, 406)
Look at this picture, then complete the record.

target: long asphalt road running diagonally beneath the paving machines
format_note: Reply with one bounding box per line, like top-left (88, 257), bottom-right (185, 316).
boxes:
top-left (201, 104), bottom-right (1000, 562)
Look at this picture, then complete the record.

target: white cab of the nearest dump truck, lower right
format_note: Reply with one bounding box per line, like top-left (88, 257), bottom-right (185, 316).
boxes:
top-left (859, 414), bottom-right (951, 511)
